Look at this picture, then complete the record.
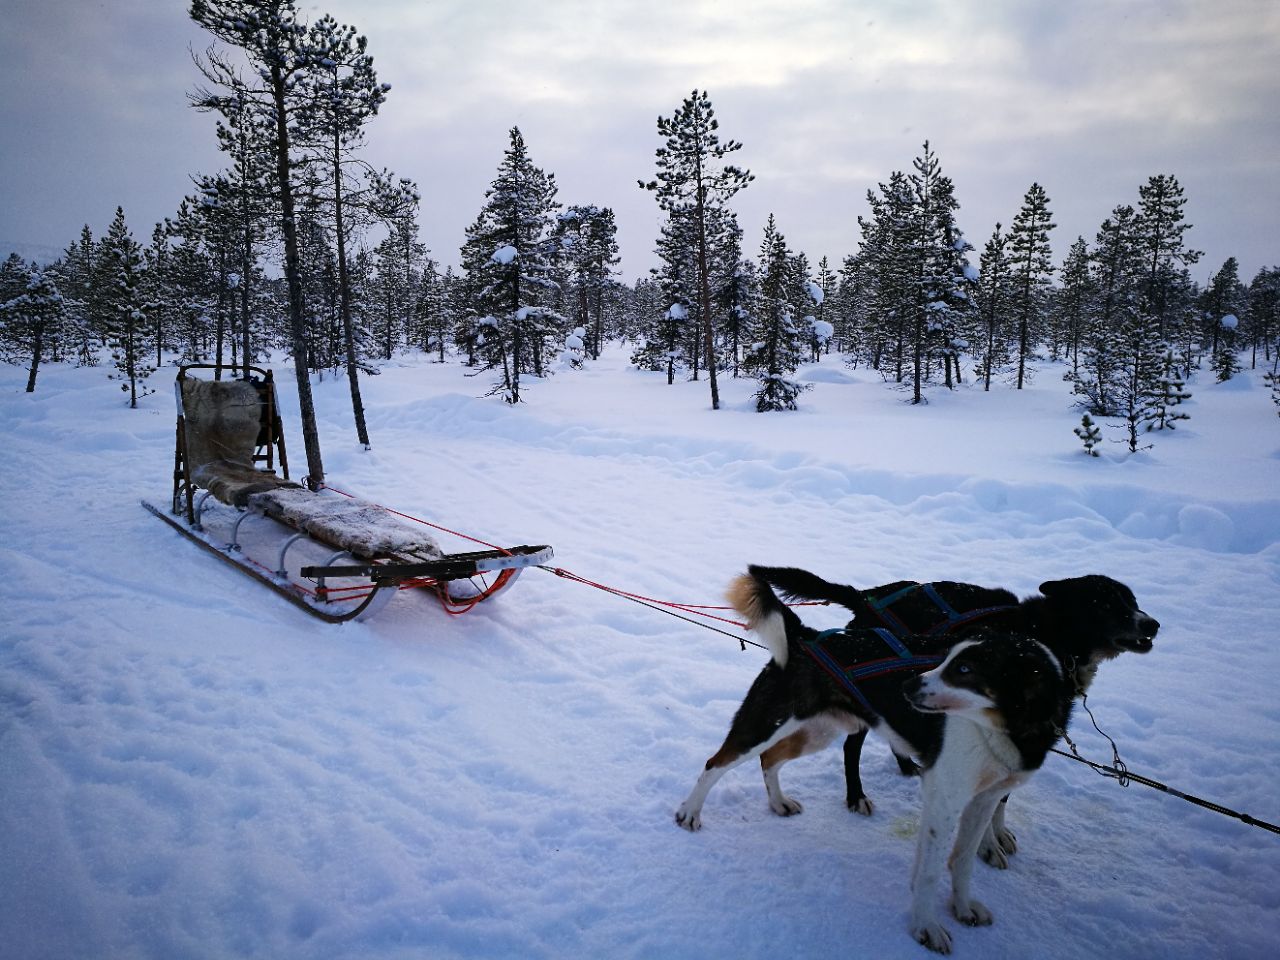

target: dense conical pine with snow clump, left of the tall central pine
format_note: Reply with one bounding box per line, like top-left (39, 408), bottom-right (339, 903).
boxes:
top-left (463, 127), bottom-right (564, 403)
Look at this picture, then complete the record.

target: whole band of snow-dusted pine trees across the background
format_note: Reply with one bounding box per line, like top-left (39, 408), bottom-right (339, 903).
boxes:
top-left (0, 0), bottom-right (1280, 455)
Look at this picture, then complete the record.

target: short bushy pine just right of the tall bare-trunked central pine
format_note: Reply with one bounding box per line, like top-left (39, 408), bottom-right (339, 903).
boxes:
top-left (744, 214), bottom-right (809, 413)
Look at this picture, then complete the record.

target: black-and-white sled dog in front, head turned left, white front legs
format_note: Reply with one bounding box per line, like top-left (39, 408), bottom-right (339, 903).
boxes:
top-left (676, 567), bottom-right (1155, 952)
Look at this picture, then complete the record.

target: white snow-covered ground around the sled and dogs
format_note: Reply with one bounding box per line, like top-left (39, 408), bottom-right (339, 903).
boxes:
top-left (0, 347), bottom-right (1280, 960)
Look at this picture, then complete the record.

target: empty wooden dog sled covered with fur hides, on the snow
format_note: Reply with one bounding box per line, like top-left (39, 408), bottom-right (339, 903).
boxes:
top-left (142, 364), bottom-right (552, 623)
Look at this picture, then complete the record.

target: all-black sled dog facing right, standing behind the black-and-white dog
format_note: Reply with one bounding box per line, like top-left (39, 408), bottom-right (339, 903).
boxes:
top-left (751, 567), bottom-right (1160, 869)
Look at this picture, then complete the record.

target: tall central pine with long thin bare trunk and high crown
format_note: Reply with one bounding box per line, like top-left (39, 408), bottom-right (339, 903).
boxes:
top-left (640, 90), bottom-right (754, 410)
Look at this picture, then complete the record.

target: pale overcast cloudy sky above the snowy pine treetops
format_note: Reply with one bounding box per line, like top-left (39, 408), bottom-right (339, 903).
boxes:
top-left (0, 0), bottom-right (1280, 282)
